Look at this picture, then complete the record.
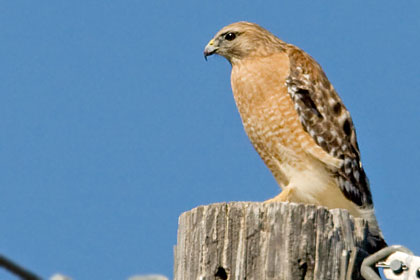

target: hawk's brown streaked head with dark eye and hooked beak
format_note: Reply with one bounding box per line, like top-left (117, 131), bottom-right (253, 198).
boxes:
top-left (204, 21), bottom-right (285, 64)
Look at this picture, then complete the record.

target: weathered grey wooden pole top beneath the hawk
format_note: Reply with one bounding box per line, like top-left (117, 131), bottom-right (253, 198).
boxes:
top-left (174, 202), bottom-right (374, 280)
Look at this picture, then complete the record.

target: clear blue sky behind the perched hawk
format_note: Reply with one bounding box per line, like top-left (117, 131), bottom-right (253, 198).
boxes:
top-left (0, 0), bottom-right (420, 279)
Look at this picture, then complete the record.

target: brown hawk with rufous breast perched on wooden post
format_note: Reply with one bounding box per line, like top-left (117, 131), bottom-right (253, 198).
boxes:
top-left (204, 22), bottom-right (386, 252)
